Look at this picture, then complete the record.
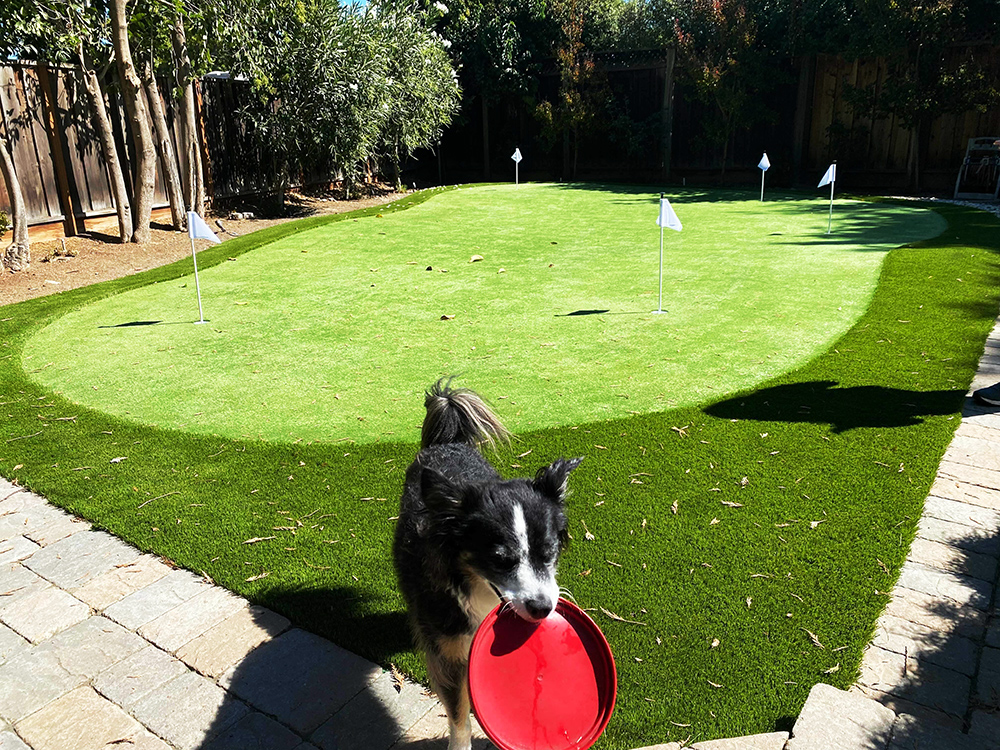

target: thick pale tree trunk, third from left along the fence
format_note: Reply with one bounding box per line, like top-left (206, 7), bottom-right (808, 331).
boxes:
top-left (111, 0), bottom-right (156, 243)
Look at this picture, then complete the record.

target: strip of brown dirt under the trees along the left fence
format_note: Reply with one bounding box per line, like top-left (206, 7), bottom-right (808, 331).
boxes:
top-left (0, 190), bottom-right (399, 305)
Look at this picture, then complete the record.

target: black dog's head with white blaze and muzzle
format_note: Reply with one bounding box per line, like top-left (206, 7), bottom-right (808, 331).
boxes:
top-left (422, 458), bottom-right (583, 622)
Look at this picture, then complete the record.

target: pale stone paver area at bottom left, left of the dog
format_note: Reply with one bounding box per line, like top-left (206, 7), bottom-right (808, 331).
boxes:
top-left (0, 479), bottom-right (490, 750)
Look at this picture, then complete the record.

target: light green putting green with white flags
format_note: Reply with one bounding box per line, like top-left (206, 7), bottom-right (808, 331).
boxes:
top-left (23, 184), bottom-right (945, 442)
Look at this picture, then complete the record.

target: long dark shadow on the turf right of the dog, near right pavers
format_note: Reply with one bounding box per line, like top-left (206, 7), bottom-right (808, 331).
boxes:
top-left (704, 380), bottom-right (964, 433)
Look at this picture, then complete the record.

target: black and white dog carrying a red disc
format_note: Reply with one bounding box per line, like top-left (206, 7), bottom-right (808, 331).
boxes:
top-left (393, 380), bottom-right (583, 750)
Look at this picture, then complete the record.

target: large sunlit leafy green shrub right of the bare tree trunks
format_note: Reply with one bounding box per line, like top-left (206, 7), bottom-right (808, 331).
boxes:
top-left (215, 0), bottom-right (459, 197)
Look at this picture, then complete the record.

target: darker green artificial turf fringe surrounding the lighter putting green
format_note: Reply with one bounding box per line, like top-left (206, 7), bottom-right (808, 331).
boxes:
top-left (0, 189), bottom-right (1000, 749)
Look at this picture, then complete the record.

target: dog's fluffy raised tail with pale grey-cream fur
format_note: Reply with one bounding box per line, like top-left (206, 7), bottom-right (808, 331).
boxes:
top-left (421, 378), bottom-right (510, 448)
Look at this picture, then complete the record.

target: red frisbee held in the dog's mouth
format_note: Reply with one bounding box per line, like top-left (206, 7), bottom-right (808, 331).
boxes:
top-left (469, 599), bottom-right (618, 750)
